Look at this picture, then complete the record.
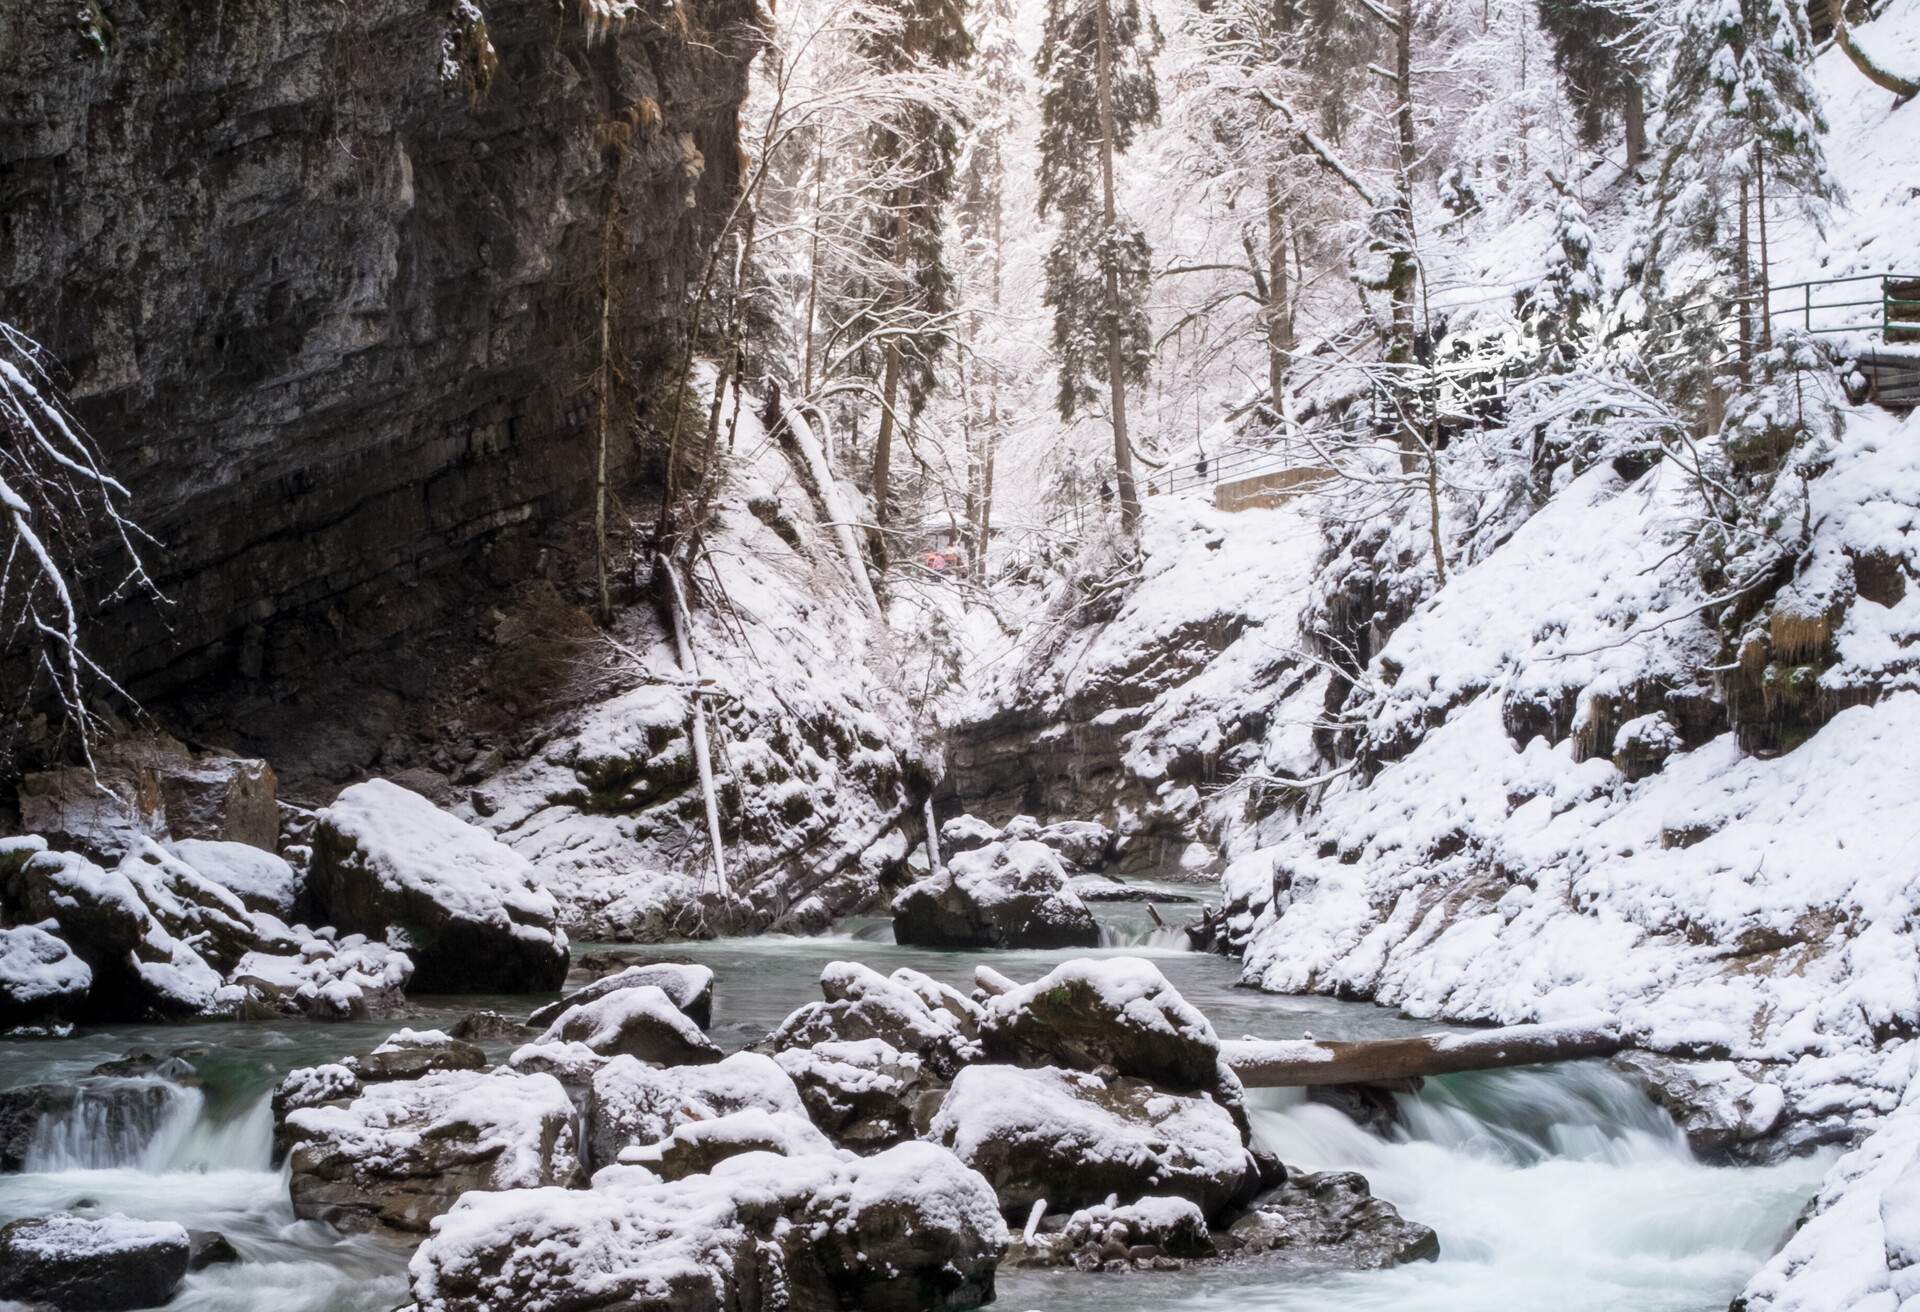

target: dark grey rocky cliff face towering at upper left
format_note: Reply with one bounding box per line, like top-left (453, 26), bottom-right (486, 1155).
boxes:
top-left (0, 0), bottom-right (758, 697)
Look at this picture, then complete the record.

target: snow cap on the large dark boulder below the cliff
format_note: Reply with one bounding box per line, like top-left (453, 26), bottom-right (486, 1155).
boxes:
top-left (317, 780), bottom-right (566, 947)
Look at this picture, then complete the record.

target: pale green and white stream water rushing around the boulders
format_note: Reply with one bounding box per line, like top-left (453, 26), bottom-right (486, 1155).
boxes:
top-left (0, 887), bottom-right (1824, 1312)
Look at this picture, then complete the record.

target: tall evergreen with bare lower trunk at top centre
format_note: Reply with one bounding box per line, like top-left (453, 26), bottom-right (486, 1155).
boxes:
top-left (1039, 0), bottom-right (1160, 532)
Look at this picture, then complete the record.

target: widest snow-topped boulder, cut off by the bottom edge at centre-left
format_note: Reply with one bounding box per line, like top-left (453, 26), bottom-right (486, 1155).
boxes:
top-left (409, 1143), bottom-right (1006, 1312)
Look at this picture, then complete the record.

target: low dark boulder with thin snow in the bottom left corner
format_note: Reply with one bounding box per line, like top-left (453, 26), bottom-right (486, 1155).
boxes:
top-left (0, 1214), bottom-right (190, 1312)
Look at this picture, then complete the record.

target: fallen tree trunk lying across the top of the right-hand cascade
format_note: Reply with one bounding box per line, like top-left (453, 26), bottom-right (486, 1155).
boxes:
top-left (1221, 1024), bottom-right (1626, 1089)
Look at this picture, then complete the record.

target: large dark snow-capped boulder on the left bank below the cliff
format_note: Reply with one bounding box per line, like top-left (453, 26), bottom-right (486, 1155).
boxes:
top-left (307, 780), bottom-right (566, 993)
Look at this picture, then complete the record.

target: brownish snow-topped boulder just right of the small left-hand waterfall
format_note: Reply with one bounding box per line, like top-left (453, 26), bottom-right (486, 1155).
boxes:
top-left (286, 1070), bottom-right (580, 1233)
